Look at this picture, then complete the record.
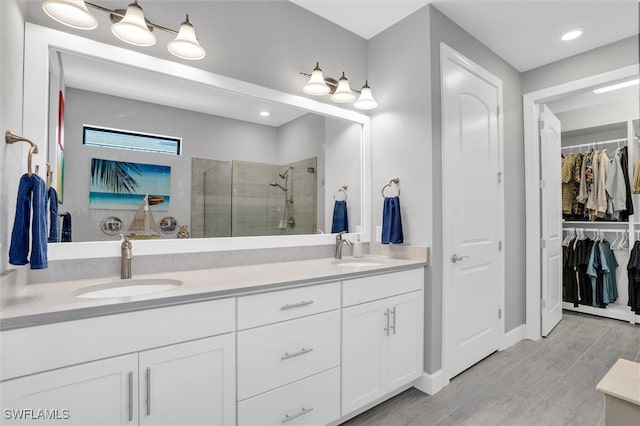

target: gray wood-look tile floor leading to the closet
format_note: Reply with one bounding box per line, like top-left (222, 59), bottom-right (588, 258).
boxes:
top-left (343, 311), bottom-right (640, 426)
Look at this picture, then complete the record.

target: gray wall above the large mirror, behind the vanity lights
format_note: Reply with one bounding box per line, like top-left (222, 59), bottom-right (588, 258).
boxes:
top-left (25, 0), bottom-right (367, 102)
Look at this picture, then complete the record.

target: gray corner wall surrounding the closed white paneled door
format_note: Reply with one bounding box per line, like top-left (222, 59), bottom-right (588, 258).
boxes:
top-left (369, 6), bottom-right (525, 373)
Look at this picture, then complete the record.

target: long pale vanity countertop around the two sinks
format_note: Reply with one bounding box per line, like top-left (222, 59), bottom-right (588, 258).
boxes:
top-left (0, 256), bottom-right (427, 330)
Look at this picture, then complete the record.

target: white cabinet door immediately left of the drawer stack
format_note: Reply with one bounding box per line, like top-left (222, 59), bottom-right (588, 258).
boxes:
top-left (140, 334), bottom-right (235, 426)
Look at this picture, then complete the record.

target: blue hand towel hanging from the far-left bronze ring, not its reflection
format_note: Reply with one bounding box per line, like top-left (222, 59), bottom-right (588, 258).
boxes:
top-left (9, 174), bottom-right (47, 269)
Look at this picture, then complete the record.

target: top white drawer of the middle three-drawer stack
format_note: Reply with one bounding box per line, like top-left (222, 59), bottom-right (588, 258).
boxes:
top-left (238, 282), bottom-right (340, 330)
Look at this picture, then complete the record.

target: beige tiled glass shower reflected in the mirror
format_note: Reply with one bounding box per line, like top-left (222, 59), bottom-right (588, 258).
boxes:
top-left (191, 157), bottom-right (318, 238)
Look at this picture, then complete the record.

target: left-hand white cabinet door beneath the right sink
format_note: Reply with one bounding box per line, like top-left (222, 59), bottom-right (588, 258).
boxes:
top-left (342, 300), bottom-right (388, 415)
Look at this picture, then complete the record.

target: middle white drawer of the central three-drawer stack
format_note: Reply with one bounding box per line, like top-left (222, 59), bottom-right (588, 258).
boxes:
top-left (238, 310), bottom-right (340, 400)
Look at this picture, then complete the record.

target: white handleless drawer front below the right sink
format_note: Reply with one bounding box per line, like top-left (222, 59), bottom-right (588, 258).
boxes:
top-left (342, 268), bottom-right (424, 306)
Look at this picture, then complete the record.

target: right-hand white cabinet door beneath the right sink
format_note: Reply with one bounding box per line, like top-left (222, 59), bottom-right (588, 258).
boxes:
top-left (387, 291), bottom-right (424, 391)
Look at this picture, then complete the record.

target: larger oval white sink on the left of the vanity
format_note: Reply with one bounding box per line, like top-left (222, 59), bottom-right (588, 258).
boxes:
top-left (73, 278), bottom-right (182, 299)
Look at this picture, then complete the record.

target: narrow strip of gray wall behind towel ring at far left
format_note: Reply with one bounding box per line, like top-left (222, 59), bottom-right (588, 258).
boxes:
top-left (0, 0), bottom-right (27, 271)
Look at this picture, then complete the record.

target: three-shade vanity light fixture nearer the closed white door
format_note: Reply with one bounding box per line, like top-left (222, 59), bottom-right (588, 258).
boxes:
top-left (300, 62), bottom-right (378, 109)
